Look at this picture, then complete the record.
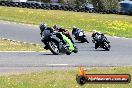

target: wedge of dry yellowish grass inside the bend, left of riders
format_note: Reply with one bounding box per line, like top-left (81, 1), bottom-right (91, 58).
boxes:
top-left (0, 39), bottom-right (44, 51)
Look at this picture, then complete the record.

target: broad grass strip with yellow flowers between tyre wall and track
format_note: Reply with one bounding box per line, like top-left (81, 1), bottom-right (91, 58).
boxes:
top-left (0, 7), bottom-right (132, 38)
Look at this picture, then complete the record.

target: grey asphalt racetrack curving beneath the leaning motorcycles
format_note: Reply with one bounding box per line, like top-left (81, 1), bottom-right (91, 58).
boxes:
top-left (0, 21), bottom-right (132, 73)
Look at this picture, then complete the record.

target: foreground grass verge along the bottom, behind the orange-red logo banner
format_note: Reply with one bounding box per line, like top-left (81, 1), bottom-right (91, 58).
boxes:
top-left (0, 67), bottom-right (132, 88)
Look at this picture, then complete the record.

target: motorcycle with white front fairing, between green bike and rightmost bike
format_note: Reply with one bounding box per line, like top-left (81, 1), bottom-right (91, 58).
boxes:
top-left (72, 30), bottom-right (89, 43)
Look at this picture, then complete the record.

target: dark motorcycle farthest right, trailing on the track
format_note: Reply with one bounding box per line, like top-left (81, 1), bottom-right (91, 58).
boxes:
top-left (92, 34), bottom-right (111, 51)
